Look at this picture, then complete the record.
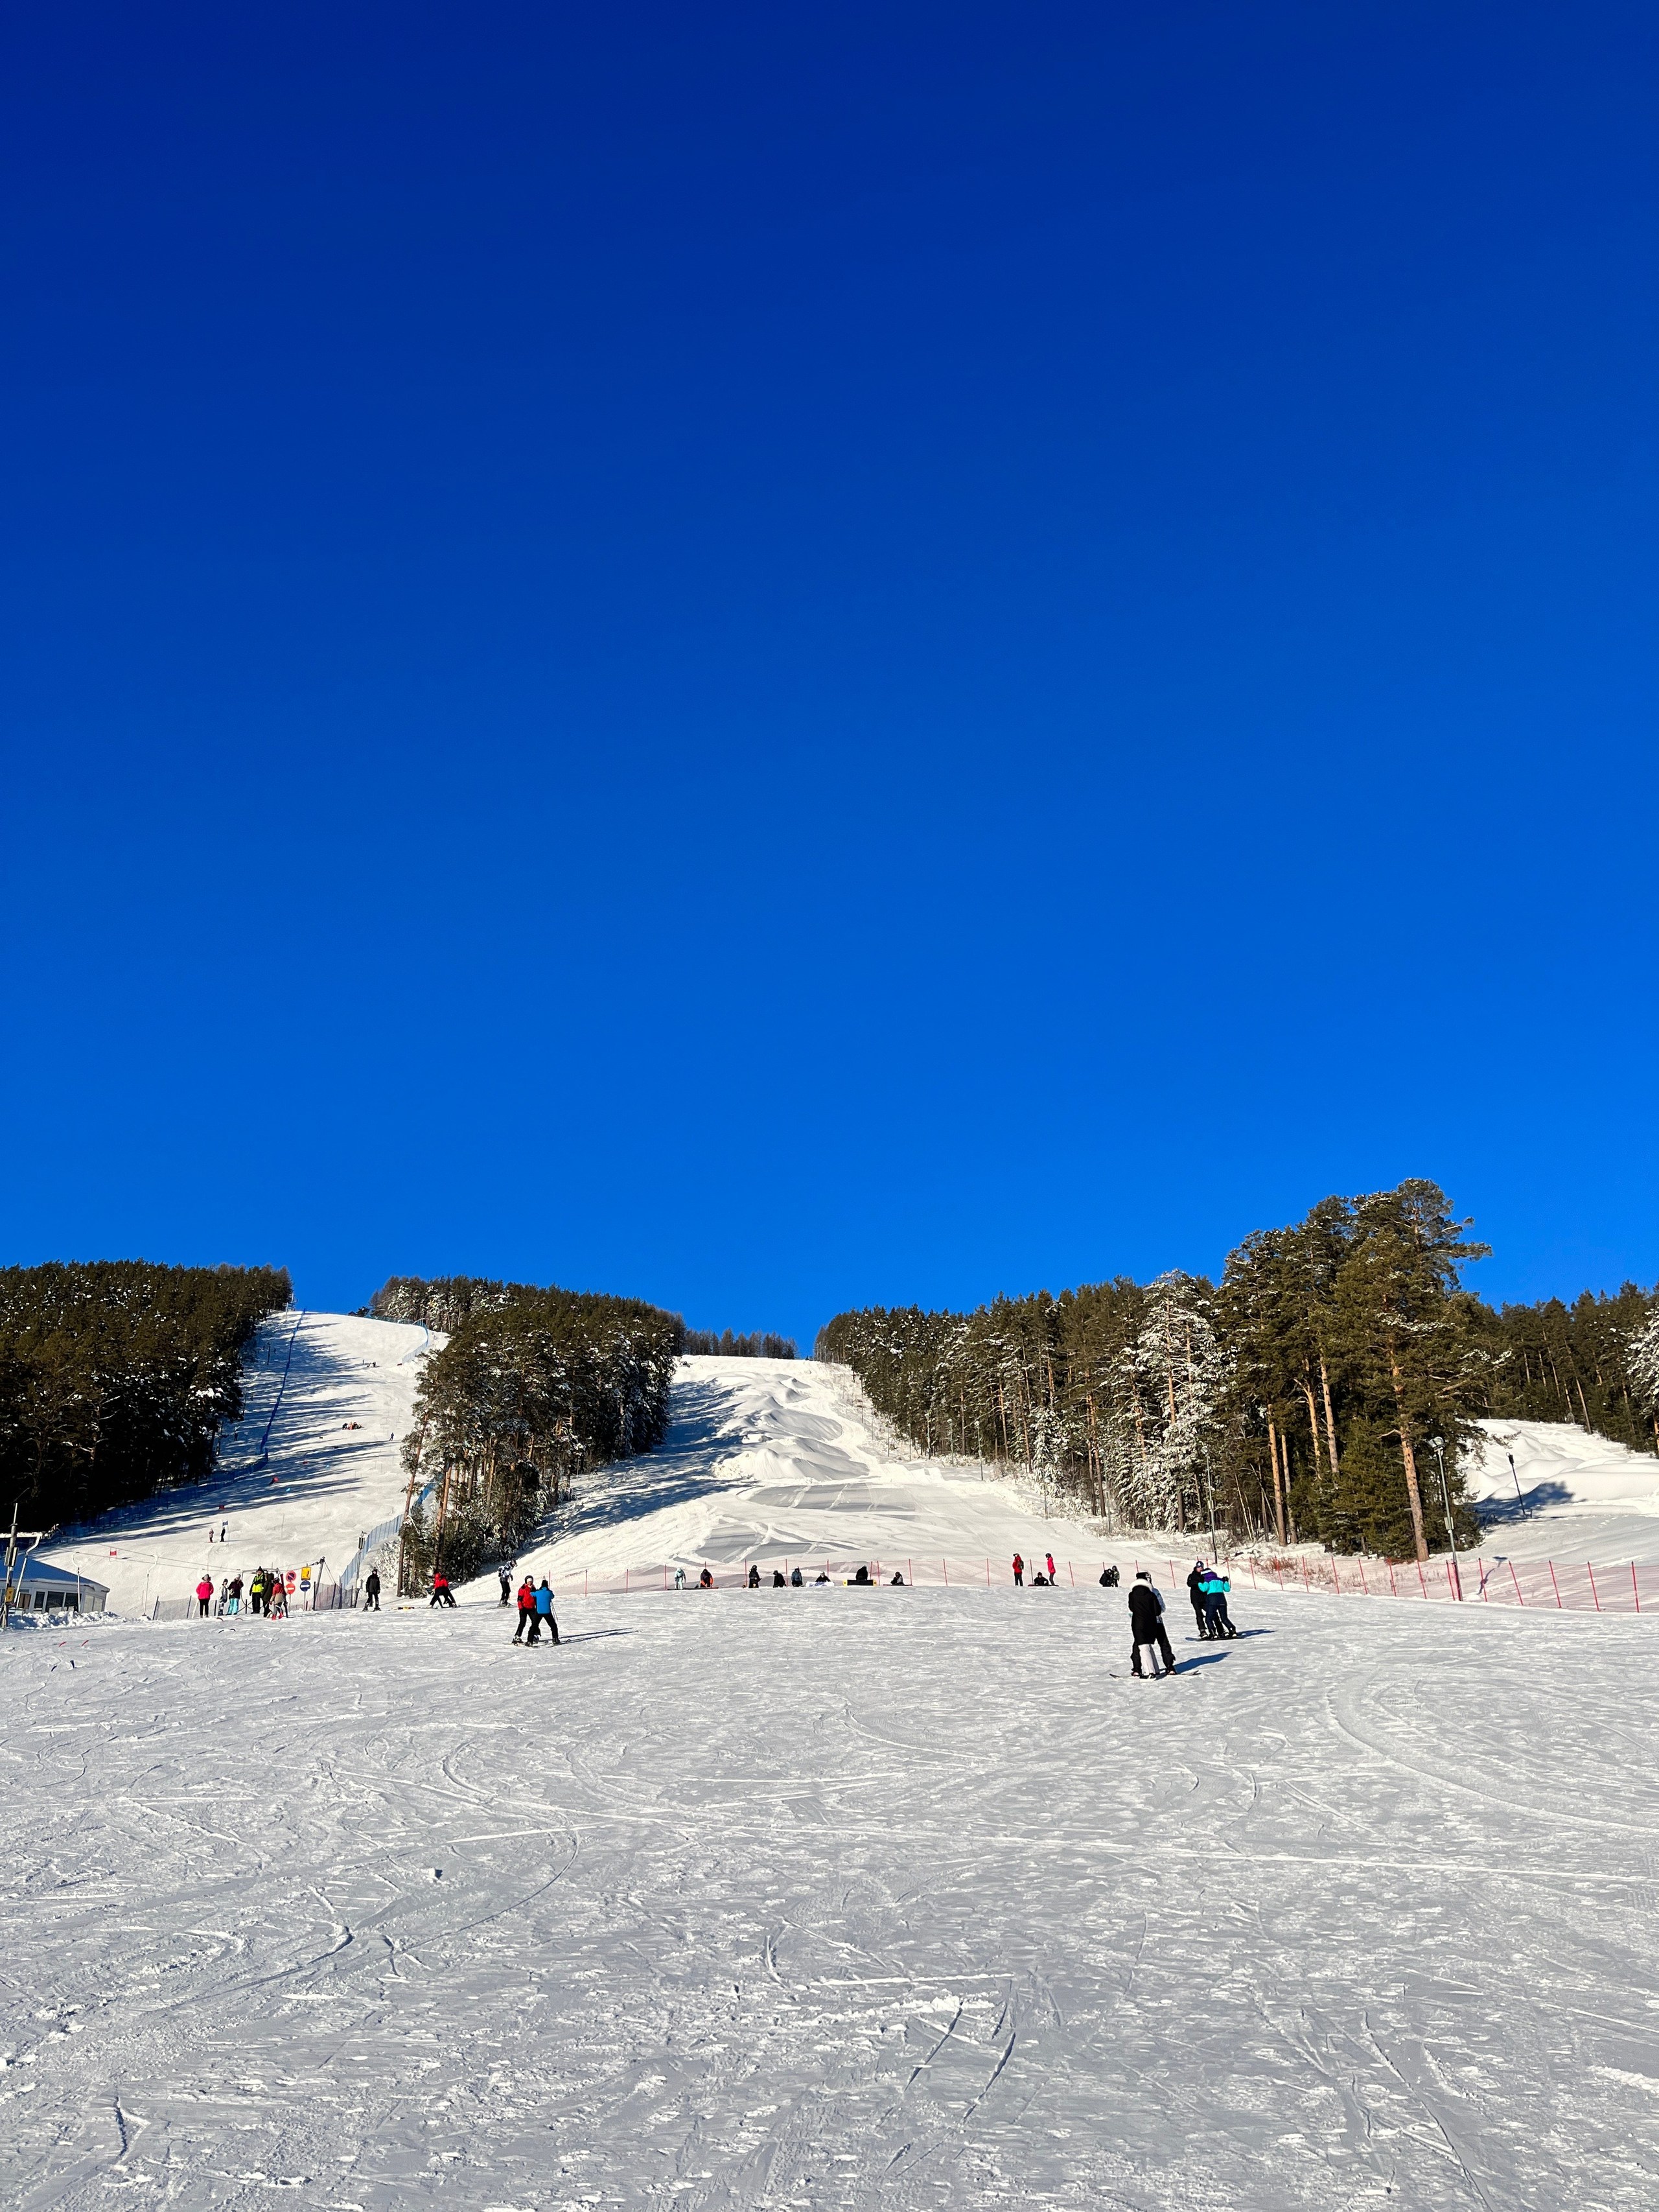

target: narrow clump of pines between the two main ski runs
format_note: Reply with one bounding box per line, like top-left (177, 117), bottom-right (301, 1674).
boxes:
top-left (391, 1276), bottom-right (686, 1586)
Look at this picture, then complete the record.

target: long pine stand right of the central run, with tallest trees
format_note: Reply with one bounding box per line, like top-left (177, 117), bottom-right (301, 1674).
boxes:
top-left (817, 1182), bottom-right (1659, 1557)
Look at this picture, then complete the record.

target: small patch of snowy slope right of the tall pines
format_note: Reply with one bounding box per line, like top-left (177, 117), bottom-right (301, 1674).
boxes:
top-left (1467, 1420), bottom-right (1659, 1562)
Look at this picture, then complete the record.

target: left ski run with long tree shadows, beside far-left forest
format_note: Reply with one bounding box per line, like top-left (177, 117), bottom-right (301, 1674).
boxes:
top-left (44, 1312), bottom-right (443, 1612)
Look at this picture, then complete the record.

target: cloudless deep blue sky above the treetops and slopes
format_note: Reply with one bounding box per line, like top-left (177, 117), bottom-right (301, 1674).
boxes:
top-left (0, 0), bottom-right (1659, 1338)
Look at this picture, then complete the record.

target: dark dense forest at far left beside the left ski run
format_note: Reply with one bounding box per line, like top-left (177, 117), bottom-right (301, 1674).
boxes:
top-left (0, 1261), bottom-right (290, 1524)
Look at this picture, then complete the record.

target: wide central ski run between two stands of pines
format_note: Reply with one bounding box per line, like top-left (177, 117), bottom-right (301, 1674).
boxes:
top-left (513, 1358), bottom-right (1099, 1595)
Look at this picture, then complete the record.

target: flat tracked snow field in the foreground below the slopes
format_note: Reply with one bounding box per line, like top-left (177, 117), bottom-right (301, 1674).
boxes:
top-left (13, 1586), bottom-right (1659, 2212)
